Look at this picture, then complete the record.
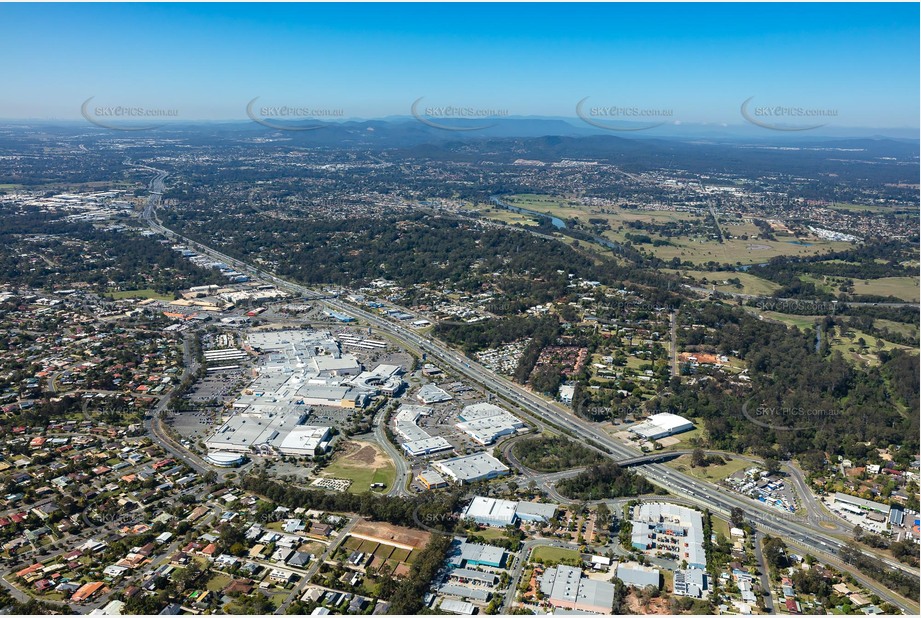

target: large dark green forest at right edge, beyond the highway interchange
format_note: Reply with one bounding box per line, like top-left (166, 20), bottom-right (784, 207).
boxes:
top-left (662, 303), bottom-right (919, 458)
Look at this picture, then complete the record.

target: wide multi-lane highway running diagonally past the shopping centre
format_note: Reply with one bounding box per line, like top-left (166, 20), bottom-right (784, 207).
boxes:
top-left (142, 168), bottom-right (918, 613)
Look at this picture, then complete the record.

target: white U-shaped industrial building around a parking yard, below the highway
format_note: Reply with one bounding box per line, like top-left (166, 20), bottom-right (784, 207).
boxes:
top-left (631, 503), bottom-right (707, 569)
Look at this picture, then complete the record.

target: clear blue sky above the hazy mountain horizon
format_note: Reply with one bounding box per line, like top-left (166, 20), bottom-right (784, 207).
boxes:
top-left (0, 3), bottom-right (921, 128)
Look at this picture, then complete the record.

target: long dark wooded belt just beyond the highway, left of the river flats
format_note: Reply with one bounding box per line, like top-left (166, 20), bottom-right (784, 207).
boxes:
top-left (164, 211), bottom-right (608, 291)
